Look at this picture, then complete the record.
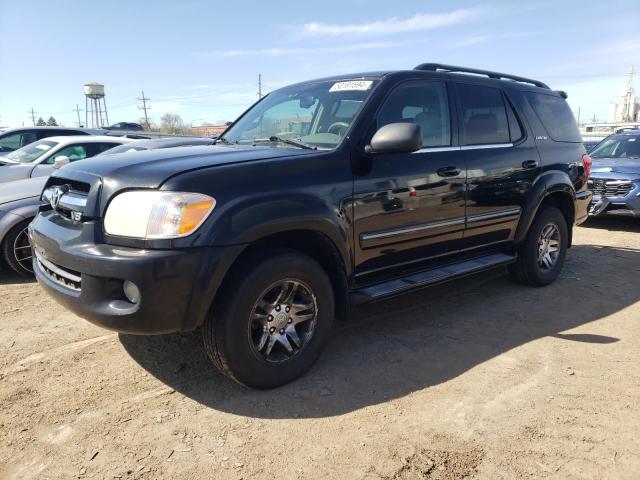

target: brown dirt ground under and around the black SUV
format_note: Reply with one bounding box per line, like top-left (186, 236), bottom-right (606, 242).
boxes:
top-left (0, 219), bottom-right (640, 480)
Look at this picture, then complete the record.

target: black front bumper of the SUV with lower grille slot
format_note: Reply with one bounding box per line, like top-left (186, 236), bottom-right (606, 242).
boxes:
top-left (29, 212), bottom-right (242, 334)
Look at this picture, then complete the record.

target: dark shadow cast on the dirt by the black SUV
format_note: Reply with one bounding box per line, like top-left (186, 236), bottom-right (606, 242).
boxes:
top-left (114, 245), bottom-right (640, 418)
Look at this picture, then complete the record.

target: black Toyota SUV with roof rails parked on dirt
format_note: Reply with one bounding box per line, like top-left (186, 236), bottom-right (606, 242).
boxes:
top-left (30, 64), bottom-right (591, 388)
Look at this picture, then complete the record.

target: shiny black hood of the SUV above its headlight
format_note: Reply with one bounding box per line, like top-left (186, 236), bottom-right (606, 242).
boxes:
top-left (58, 145), bottom-right (316, 188)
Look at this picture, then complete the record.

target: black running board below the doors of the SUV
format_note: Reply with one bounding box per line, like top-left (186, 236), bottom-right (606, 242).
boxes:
top-left (351, 253), bottom-right (516, 303)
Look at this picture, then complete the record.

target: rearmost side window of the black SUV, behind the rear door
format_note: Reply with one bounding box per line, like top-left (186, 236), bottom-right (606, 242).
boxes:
top-left (526, 92), bottom-right (582, 142)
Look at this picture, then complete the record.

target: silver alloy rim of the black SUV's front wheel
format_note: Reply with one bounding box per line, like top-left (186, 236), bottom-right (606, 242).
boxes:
top-left (249, 278), bottom-right (318, 363)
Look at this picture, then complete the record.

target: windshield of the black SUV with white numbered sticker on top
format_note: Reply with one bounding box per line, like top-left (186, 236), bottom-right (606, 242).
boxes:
top-left (218, 80), bottom-right (377, 149)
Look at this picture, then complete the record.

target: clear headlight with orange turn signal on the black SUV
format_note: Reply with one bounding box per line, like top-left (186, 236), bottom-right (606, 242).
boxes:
top-left (104, 190), bottom-right (216, 239)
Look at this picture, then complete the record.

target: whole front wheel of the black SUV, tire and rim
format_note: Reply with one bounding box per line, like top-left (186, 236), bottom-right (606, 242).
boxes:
top-left (202, 250), bottom-right (335, 389)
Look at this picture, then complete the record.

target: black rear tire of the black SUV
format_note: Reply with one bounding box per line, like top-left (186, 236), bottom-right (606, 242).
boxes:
top-left (509, 206), bottom-right (569, 287)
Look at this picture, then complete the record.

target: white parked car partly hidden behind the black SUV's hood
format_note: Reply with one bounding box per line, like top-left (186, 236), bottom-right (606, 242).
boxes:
top-left (0, 135), bottom-right (133, 183)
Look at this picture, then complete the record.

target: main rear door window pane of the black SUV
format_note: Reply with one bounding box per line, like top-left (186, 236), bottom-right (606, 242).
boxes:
top-left (458, 84), bottom-right (511, 145)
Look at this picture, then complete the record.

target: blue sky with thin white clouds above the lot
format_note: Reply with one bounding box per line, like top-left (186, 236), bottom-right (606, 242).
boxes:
top-left (0, 0), bottom-right (640, 126)
